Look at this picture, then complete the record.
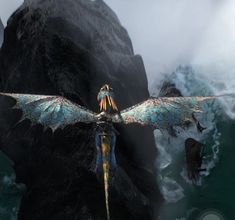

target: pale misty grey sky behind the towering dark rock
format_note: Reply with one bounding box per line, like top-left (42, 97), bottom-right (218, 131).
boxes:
top-left (0, 0), bottom-right (235, 87)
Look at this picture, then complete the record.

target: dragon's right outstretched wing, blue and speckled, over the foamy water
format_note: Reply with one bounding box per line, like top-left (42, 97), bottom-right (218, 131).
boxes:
top-left (113, 96), bottom-right (216, 129)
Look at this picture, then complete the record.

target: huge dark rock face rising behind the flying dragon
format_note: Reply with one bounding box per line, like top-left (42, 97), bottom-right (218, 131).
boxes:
top-left (0, 0), bottom-right (162, 220)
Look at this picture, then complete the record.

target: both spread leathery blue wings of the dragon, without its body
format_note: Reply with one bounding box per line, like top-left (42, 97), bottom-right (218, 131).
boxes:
top-left (0, 93), bottom-right (217, 131)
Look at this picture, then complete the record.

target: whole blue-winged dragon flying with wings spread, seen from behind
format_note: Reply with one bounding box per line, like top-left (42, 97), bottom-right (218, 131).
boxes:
top-left (0, 84), bottom-right (231, 220)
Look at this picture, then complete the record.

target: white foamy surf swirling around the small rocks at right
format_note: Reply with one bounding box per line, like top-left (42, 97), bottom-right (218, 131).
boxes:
top-left (152, 66), bottom-right (229, 203)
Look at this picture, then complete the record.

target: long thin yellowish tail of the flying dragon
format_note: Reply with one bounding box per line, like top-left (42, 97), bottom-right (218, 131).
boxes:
top-left (101, 136), bottom-right (110, 220)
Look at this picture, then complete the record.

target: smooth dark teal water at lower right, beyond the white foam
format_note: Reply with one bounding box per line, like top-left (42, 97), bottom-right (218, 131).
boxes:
top-left (161, 119), bottom-right (235, 220)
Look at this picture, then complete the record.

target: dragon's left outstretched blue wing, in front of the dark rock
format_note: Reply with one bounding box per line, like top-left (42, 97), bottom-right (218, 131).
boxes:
top-left (0, 93), bottom-right (97, 131)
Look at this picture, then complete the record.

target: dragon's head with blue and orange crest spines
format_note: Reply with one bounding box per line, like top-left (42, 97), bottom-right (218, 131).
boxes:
top-left (97, 84), bottom-right (118, 112)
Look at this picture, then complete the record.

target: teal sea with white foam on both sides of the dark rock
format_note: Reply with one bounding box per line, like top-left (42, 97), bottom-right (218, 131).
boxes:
top-left (0, 66), bottom-right (235, 220)
